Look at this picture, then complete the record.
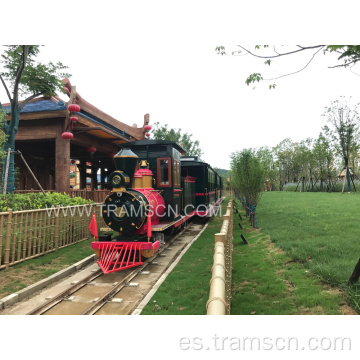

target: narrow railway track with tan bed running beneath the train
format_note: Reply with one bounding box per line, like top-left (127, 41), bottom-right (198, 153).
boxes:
top-left (22, 218), bottom-right (204, 315)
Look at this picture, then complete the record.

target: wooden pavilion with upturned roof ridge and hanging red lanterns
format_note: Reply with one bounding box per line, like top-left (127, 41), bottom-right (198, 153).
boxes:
top-left (3, 79), bottom-right (149, 197)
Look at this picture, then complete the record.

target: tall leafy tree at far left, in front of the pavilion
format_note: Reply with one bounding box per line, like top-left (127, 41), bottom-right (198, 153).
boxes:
top-left (0, 45), bottom-right (70, 193)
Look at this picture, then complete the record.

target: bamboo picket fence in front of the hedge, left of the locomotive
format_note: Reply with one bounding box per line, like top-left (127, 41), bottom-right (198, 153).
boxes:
top-left (0, 204), bottom-right (104, 269)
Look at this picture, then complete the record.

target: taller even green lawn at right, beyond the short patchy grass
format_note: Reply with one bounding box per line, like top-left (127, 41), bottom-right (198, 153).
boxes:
top-left (257, 192), bottom-right (360, 287)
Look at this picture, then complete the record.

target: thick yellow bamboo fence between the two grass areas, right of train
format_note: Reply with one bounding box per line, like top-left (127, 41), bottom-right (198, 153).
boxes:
top-left (206, 198), bottom-right (233, 315)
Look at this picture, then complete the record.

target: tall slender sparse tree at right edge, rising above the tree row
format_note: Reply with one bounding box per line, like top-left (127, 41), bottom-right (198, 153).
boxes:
top-left (323, 97), bottom-right (360, 192)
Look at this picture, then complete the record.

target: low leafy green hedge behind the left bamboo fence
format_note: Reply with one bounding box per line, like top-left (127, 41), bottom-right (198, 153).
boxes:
top-left (0, 192), bottom-right (92, 212)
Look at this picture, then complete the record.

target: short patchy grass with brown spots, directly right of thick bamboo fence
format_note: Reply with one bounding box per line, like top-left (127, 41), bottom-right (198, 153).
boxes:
top-left (231, 211), bottom-right (352, 315)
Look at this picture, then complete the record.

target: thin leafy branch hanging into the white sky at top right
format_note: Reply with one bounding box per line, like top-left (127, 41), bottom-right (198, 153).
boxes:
top-left (215, 45), bottom-right (360, 89)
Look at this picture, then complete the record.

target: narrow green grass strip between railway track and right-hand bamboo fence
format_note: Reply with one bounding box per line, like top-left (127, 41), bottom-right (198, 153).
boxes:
top-left (141, 198), bottom-right (229, 315)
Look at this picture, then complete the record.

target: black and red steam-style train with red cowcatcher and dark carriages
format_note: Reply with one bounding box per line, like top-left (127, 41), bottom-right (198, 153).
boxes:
top-left (91, 140), bottom-right (222, 274)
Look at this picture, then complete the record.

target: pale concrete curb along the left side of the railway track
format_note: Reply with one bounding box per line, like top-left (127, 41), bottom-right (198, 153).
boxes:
top-left (0, 254), bottom-right (97, 310)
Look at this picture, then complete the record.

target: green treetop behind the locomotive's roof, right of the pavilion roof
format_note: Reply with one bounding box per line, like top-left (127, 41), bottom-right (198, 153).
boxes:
top-left (152, 122), bottom-right (203, 158)
